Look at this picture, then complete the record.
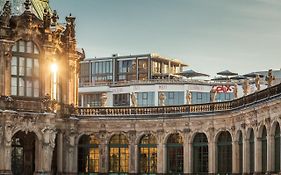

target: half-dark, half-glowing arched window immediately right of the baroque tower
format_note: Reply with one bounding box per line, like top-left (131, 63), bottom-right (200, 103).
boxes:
top-left (77, 135), bottom-right (99, 174)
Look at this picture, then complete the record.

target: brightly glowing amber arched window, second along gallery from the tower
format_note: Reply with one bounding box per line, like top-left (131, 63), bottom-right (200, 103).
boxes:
top-left (109, 134), bottom-right (129, 173)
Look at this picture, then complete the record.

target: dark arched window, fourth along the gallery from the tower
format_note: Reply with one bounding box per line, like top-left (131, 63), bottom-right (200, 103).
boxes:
top-left (167, 133), bottom-right (183, 173)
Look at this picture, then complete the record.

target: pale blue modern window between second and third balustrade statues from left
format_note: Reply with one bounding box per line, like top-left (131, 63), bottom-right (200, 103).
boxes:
top-left (136, 92), bottom-right (155, 106)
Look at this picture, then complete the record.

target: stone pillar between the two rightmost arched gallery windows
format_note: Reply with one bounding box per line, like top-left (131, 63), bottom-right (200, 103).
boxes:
top-left (267, 132), bottom-right (275, 172)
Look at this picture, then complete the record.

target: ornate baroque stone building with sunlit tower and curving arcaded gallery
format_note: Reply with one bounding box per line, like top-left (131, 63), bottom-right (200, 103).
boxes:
top-left (0, 0), bottom-right (281, 175)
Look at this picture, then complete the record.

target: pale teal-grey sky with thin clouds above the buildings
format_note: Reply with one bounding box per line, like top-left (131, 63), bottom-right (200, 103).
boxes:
top-left (50, 0), bottom-right (281, 76)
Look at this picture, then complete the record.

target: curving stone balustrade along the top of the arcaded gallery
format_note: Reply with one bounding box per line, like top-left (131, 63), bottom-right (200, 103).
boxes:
top-left (77, 84), bottom-right (281, 117)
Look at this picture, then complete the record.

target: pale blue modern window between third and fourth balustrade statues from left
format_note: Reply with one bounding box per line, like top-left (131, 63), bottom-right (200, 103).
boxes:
top-left (158, 91), bottom-right (184, 106)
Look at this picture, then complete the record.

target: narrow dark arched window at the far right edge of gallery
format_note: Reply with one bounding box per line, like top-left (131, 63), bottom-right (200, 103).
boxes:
top-left (274, 123), bottom-right (281, 173)
